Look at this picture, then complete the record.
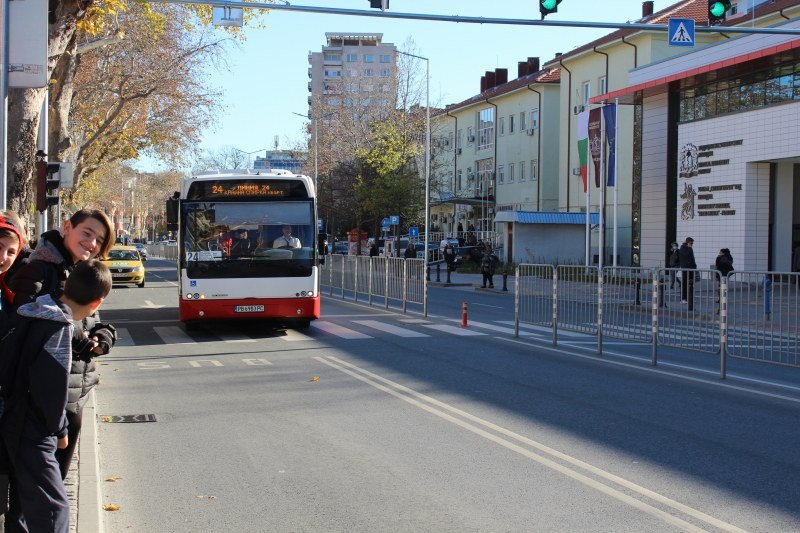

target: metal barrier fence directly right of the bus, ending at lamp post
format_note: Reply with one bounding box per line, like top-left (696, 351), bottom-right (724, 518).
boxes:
top-left (320, 255), bottom-right (425, 312)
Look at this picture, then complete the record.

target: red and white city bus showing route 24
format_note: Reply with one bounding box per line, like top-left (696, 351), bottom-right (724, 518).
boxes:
top-left (167, 170), bottom-right (321, 327)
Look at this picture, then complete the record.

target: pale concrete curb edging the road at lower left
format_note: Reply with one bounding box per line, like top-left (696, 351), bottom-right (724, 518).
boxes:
top-left (77, 389), bottom-right (104, 533)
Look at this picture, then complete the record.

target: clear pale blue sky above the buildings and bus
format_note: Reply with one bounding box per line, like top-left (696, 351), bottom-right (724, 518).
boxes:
top-left (137, 0), bottom-right (660, 171)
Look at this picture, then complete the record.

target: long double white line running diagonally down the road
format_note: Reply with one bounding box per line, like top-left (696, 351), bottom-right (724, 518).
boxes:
top-left (314, 356), bottom-right (744, 532)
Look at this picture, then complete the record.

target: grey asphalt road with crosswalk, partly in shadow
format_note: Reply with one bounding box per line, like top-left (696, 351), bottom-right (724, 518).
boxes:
top-left (92, 260), bottom-right (800, 532)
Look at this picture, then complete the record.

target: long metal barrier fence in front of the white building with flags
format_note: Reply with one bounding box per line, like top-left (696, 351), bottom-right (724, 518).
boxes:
top-left (514, 264), bottom-right (800, 378)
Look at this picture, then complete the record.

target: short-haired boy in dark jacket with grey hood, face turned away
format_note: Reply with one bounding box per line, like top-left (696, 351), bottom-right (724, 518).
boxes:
top-left (0, 259), bottom-right (111, 533)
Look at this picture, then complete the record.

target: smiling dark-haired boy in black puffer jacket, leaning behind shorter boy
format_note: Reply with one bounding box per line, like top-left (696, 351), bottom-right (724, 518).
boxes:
top-left (8, 209), bottom-right (117, 478)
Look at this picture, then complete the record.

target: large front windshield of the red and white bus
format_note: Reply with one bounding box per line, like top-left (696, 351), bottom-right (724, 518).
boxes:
top-left (180, 200), bottom-right (316, 279)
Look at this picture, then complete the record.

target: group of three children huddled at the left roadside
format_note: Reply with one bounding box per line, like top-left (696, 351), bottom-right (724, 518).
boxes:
top-left (0, 209), bottom-right (116, 533)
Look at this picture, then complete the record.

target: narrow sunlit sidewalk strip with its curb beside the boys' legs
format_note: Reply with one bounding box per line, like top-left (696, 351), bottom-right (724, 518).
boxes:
top-left (64, 390), bottom-right (104, 533)
